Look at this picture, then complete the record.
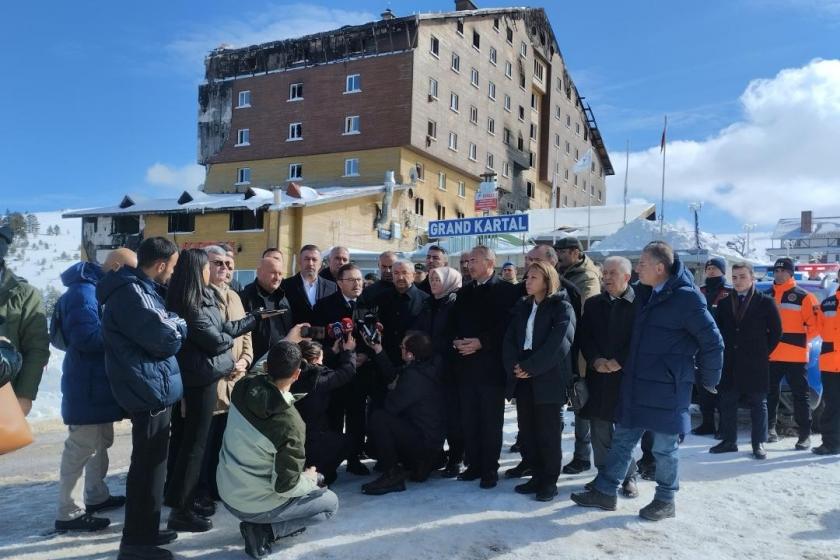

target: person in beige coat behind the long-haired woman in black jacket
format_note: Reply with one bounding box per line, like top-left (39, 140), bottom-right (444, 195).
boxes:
top-left (196, 245), bottom-right (254, 513)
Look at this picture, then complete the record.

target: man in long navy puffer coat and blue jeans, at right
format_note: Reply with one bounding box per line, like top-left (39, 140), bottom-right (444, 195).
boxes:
top-left (572, 241), bottom-right (723, 521)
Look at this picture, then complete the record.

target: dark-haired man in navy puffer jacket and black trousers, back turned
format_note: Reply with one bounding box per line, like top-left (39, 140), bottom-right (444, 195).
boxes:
top-left (96, 237), bottom-right (187, 560)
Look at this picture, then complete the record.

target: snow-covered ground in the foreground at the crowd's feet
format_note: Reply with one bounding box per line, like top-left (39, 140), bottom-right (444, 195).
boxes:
top-left (0, 408), bottom-right (840, 560)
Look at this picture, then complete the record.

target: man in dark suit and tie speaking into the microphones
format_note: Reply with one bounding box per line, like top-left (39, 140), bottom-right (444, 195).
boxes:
top-left (314, 263), bottom-right (376, 475)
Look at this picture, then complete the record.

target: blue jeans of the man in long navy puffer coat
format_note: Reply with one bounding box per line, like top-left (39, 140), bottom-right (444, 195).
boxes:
top-left (595, 424), bottom-right (680, 502)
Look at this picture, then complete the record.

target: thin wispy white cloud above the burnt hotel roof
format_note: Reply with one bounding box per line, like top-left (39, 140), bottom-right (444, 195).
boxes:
top-left (166, 4), bottom-right (379, 76)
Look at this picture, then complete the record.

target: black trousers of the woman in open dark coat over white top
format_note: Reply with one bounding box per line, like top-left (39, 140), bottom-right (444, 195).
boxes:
top-left (514, 379), bottom-right (563, 486)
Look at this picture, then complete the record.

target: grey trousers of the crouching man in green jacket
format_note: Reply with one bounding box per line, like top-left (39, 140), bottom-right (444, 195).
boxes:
top-left (225, 488), bottom-right (338, 539)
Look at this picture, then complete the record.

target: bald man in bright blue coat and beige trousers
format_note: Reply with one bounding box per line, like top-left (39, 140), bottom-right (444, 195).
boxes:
top-left (53, 249), bottom-right (137, 531)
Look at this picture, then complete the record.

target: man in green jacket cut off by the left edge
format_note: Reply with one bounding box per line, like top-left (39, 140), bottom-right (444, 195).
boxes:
top-left (0, 226), bottom-right (50, 414)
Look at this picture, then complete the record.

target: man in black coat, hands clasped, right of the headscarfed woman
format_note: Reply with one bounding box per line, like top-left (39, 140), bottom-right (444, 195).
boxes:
top-left (449, 246), bottom-right (518, 488)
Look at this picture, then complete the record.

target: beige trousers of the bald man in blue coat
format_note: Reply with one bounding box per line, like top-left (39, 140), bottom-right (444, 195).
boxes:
top-left (56, 422), bottom-right (114, 521)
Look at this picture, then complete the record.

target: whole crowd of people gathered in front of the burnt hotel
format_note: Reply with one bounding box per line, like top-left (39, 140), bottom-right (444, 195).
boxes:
top-left (0, 221), bottom-right (840, 560)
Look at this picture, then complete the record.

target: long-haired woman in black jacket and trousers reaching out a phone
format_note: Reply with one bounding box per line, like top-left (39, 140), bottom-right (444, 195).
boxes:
top-left (165, 249), bottom-right (259, 532)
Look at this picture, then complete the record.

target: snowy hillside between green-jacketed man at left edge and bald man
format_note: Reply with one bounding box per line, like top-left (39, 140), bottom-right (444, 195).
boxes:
top-left (6, 210), bottom-right (82, 422)
